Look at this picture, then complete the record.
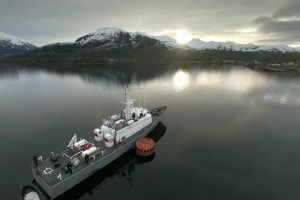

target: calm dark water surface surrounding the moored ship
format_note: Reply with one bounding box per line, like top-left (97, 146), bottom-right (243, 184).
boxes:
top-left (0, 64), bottom-right (300, 200)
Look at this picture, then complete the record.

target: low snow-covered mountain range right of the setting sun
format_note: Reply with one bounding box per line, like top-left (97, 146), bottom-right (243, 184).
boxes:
top-left (186, 39), bottom-right (300, 53)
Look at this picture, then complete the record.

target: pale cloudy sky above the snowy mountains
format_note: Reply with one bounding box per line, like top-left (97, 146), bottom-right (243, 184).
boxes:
top-left (0, 0), bottom-right (300, 46)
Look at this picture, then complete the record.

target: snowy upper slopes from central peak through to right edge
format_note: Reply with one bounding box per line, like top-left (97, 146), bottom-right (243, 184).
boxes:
top-left (75, 28), bottom-right (300, 52)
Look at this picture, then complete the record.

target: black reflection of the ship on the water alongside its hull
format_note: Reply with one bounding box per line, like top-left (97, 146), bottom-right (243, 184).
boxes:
top-left (56, 122), bottom-right (167, 200)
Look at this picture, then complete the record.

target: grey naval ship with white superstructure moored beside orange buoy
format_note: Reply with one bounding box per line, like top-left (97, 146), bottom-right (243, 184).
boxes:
top-left (31, 97), bottom-right (167, 199)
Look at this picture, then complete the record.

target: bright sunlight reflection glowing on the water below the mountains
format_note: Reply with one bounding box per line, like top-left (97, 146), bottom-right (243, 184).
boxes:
top-left (146, 69), bottom-right (272, 94)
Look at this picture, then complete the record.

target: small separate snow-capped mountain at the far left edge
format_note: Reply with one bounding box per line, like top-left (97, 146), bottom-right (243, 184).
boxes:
top-left (0, 32), bottom-right (35, 55)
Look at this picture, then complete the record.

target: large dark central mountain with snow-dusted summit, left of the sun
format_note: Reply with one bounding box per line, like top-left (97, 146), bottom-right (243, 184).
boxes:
top-left (28, 28), bottom-right (169, 59)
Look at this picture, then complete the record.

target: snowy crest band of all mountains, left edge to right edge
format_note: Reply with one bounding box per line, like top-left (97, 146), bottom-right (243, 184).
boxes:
top-left (0, 27), bottom-right (300, 53)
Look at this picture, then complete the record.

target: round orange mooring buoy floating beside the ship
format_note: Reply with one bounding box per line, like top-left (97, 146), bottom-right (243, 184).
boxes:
top-left (135, 138), bottom-right (155, 156)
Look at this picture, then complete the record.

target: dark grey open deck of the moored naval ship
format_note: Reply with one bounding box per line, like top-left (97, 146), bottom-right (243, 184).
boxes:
top-left (32, 106), bottom-right (166, 186)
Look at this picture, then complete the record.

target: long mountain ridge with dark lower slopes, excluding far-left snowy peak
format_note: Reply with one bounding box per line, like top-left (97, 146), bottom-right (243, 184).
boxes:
top-left (1, 28), bottom-right (300, 63)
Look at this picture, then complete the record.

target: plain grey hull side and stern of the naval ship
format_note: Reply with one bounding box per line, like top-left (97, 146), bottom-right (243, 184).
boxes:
top-left (32, 106), bottom-right (167, 199)
